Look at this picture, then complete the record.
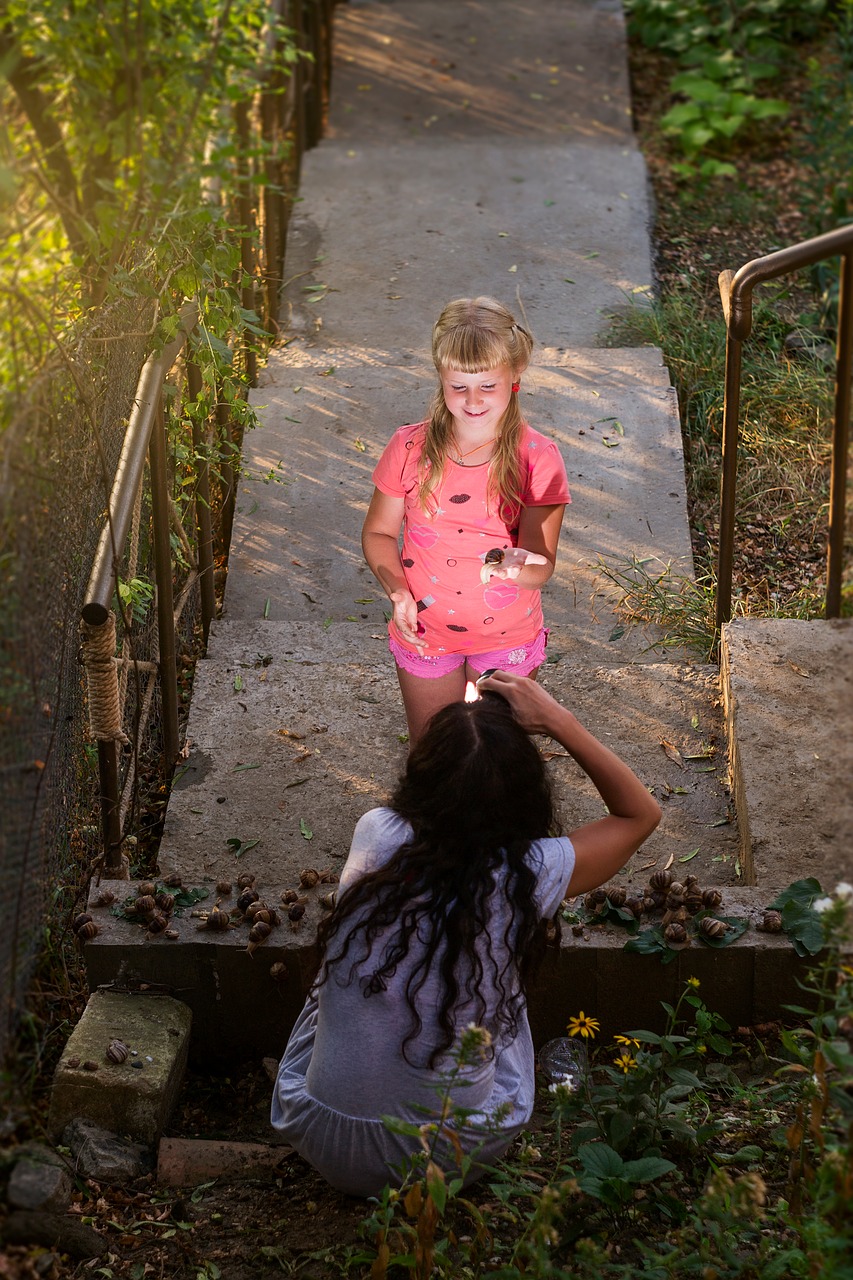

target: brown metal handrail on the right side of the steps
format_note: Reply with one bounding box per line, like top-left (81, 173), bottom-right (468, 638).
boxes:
top-left (716, 227), bottom-right (853, 627)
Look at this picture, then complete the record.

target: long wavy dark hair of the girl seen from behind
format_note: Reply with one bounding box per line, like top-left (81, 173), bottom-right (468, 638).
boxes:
top-left (312, 694), bottom-right (561, 1068)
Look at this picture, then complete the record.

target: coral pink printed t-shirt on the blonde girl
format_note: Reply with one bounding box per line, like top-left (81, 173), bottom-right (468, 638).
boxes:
top-left (373, 422), bottom-right (571, 655)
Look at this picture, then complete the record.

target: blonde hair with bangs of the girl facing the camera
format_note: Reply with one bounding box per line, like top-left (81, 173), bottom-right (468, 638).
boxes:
top-left (418, 297), bottom-right (533, 526)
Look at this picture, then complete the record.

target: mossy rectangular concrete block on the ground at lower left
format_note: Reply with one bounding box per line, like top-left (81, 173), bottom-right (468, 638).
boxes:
top-left (47, 991), bottom-right (192, 1144)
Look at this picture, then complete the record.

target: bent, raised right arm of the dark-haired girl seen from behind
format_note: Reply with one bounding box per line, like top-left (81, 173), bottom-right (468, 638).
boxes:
top-left (478, 671), bottom-right (661, 895)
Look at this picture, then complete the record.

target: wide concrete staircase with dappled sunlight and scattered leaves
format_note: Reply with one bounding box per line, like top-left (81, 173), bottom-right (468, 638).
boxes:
top-left (81, 0), bottom-right (853, 1056)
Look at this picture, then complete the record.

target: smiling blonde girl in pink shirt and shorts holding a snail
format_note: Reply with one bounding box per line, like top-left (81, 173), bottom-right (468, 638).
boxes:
top-left (361, 297), bottom-right (571, 745)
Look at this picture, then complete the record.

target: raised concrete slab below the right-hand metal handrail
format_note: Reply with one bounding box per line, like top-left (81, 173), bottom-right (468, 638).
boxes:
top-left (721, 618), bottom-right (853, 891)
